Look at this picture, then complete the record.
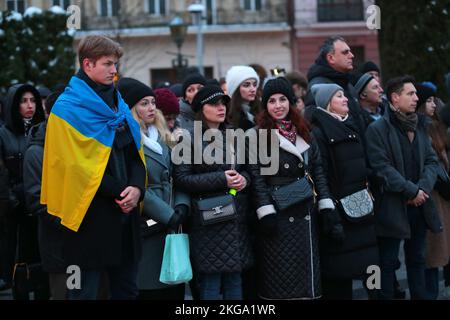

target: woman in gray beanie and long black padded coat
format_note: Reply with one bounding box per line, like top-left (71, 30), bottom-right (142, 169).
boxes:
top-left (312, 84), bottom-right (378, 299)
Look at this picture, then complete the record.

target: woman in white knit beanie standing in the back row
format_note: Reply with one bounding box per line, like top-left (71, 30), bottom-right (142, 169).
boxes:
top-left (226, 66), bottom-right (260, 131)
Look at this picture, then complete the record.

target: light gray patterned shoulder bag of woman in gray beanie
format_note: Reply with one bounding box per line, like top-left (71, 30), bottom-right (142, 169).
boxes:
top-left (339, 189), bottom-right (373, 220)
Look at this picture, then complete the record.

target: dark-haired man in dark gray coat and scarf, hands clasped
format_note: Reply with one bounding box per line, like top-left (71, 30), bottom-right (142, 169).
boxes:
top-left (366, 76), bottom-right (442, 299)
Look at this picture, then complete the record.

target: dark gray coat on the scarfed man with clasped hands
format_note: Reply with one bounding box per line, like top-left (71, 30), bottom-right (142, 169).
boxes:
top-left (366, 109), bottom-right (442, 239)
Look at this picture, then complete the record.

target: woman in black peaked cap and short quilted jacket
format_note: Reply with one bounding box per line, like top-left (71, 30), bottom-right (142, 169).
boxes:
top-left (172, 85), bottom-right (253, 300)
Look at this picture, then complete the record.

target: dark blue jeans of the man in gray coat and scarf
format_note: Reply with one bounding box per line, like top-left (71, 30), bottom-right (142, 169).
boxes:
top-left (378, 207), bottom-right (428, 300)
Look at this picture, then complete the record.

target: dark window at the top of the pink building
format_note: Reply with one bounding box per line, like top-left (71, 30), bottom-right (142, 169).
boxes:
top-left (317, 0), bottom-right (364, 22)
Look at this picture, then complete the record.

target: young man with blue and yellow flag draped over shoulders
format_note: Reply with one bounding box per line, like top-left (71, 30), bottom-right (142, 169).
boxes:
top-left (41, 36), bottom-right (146, 299)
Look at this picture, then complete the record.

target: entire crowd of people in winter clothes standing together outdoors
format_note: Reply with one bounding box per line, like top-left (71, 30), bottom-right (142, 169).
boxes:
top-left (0, 35), bottom-right (450, 300)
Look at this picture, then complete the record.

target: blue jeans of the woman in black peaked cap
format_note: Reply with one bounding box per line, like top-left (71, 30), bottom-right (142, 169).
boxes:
top-left (198, 272), bottom-right (242, 300)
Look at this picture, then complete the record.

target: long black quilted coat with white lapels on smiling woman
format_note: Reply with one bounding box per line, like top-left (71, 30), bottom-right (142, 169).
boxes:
top-left (249, 129), bottom-right (329, 299)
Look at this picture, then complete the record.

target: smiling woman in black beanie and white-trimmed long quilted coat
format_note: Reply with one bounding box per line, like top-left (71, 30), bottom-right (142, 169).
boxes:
top-left (248, 78), bottom-right (340, 299)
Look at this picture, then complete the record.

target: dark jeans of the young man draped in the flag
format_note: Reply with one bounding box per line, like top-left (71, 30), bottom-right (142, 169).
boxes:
top-left (67, 262), bottom-right (138, 300)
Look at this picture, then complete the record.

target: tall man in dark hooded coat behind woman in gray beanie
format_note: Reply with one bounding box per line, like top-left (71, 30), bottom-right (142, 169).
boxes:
top-left (305, 37), bottom-right (366, 134)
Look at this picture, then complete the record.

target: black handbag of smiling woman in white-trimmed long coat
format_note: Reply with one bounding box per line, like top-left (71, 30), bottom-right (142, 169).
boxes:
top-left (271, 175), bottom-right (314, 211)
